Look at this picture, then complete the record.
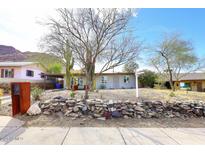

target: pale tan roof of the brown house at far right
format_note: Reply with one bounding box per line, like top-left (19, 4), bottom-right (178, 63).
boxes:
top-left (174, 73), bottom-right (205, 81)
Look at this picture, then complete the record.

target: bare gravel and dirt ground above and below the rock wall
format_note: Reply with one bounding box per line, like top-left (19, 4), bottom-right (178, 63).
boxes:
top-left (0, 89), bottom-right (205, 127)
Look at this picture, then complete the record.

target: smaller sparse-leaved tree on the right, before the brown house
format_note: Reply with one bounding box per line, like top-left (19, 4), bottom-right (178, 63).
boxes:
top-left (151, 34), bottom-right (201, 91)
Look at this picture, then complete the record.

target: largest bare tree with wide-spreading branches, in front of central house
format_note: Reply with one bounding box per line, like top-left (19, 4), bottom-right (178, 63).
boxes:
top-left (43, 8), bottom-right (143, 98)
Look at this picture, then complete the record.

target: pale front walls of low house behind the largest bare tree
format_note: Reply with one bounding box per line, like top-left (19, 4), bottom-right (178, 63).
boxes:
top-left (64, 72), bottom-right (136, 89)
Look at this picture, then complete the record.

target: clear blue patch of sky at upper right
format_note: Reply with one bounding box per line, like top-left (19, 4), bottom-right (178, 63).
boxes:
top-left (131, 9), bottom-right (205, 57)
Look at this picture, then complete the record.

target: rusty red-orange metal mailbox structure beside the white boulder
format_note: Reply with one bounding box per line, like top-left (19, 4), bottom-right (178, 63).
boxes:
top-left (11, 82), bottom-right (31, 116)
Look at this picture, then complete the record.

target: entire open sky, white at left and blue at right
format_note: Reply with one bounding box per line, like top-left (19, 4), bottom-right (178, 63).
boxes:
top-left (0, 8), bottom-right (205, 70)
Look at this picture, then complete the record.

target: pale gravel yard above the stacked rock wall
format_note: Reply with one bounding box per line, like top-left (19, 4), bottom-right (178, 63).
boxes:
top-left (42, 88), bottom-right (205, 101)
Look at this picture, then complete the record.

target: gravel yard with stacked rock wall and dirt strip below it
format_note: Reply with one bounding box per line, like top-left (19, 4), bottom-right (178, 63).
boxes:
top-left (0, 88), bottom-right (205, 127)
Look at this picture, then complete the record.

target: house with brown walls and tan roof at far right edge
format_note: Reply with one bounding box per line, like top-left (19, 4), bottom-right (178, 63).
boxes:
top-left (174, 73), bottom-right (205, 92)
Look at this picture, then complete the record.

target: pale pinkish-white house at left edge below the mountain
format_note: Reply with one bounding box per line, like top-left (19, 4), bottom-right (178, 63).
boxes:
top-left (0, 62), bottom-right (44, 83)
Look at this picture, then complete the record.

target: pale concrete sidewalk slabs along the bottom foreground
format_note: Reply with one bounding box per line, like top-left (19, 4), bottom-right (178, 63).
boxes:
top-left (0, 116), bottom-right (205, 145)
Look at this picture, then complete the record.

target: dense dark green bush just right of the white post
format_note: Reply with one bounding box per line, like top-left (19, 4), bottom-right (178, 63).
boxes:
top-left (138, 70), bottom-right (157, 88)
